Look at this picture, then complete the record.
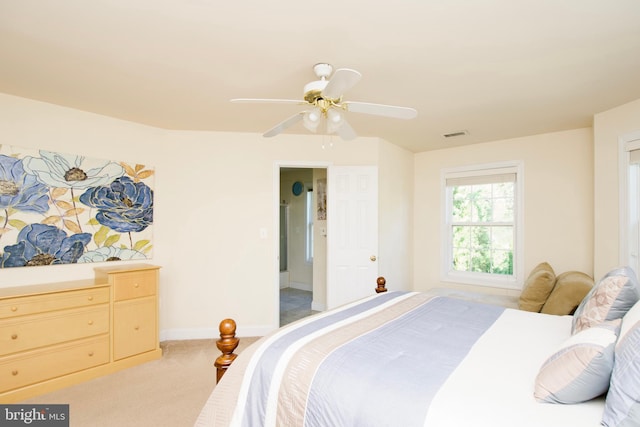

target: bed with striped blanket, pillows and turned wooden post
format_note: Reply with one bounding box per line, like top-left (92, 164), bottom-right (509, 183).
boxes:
top-left (196, 275), bottom-right (640, 427)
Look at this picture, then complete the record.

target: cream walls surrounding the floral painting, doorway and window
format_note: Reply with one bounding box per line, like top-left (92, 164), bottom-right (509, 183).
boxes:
top-left (6, 89), bottom-right (640, 339)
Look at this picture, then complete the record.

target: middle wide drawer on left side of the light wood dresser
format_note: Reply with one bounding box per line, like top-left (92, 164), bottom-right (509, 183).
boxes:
top-left (0, 304), bottom-right (109, 356)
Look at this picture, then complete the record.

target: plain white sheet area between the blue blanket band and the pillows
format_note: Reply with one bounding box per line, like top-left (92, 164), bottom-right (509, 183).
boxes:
top-left (425, 309), bottom-right (604, 427)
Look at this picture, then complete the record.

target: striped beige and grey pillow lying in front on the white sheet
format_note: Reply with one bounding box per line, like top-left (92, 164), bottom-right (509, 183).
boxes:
top-left (533, 319), bottom-right (622, 403)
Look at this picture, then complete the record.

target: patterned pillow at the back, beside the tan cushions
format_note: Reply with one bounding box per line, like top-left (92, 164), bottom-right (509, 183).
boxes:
top-left (571, 267), bottom-right (640, 334)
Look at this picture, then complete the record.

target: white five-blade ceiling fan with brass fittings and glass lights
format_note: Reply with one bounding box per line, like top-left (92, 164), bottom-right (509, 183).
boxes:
top-left (231, 63), bottom-right (418, 140)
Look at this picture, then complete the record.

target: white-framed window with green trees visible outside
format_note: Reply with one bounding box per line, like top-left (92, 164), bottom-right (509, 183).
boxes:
top-left (443, 163), bottom-right (522, 288)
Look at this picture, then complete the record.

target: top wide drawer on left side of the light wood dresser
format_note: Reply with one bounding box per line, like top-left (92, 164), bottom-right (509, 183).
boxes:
top-left (0, 286), bottom-right (109, 319)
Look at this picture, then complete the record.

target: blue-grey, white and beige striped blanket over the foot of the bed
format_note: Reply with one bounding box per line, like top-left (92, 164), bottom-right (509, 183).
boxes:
top-left (195, 292), bottom-right (504, 427)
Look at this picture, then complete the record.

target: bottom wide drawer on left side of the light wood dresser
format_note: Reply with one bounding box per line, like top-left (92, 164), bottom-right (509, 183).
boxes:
top-left (0, 335), bottom-right (109, 392)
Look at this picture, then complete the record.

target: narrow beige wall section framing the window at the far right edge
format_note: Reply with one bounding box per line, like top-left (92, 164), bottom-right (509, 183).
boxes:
top-left (593, 100), bottom-right (640, 278)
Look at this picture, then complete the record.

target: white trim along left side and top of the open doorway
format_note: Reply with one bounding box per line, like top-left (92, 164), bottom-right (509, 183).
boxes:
top-left (272, 160), bottom-right (333, 329)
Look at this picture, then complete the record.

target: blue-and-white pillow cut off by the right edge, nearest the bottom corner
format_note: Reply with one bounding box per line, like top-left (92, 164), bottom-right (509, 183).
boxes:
top-left (602, 302), bottom-right (640, 427)
